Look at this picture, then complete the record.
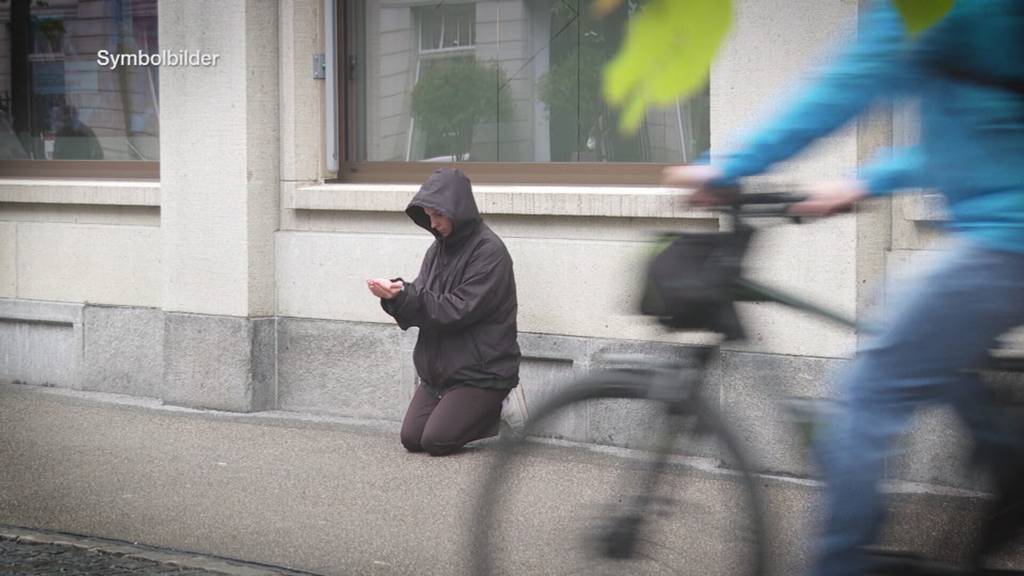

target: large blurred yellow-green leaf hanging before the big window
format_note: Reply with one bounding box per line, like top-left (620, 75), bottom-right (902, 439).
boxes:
top-left (604, 0), bottom-right (732, 133)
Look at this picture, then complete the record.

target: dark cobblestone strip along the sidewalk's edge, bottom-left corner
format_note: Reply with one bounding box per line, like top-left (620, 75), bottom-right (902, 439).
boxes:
top-left (0, 525), bottom-right (315, 576)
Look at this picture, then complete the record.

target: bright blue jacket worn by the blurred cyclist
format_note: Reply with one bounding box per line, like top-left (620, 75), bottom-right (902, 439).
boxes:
top-left (716, 0), bottom-right (1024, 252)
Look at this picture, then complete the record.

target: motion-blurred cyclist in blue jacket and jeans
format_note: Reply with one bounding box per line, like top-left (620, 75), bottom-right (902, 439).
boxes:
top-left (664, 0), bottom-right (1024, 576)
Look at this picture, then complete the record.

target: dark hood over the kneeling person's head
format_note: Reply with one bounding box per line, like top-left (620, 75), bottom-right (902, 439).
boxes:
top-left (406, 168), bottom-right (481, 242)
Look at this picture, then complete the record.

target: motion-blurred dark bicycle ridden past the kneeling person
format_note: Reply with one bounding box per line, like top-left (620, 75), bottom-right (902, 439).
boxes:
top-left (470, 191), bottom-right (1024, 576)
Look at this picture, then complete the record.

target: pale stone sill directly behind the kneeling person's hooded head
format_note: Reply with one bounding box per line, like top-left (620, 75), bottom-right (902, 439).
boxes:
top-left (288, 183), bottom-right (710, 218)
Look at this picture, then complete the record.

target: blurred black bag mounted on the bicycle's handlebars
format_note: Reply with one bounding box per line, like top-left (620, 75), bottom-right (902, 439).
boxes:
top-left (640, 227), bottom-right (753, 340)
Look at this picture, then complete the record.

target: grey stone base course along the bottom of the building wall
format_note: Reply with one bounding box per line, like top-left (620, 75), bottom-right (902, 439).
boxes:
top-left (0, 299), bottom-right (999, 489)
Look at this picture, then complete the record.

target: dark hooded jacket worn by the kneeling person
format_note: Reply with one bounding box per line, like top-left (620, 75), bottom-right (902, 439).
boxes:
top-left (381, 168), bottom-right (520, 392)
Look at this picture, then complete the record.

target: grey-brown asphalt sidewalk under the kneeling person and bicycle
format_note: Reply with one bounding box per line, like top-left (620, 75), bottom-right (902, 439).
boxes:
top-left (0, 384), bottom-right (1007, 576)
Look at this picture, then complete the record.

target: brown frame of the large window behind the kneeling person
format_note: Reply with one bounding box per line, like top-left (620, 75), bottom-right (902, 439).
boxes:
top-left (325, 0), bottom-right (692, 187)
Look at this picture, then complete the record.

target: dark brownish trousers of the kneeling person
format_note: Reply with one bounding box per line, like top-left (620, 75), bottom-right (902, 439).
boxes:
top-left (401, 385), bottom-right (509, 456)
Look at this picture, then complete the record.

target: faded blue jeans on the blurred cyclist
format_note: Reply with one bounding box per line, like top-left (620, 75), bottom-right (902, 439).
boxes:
top-left (814, 241), bottom-right (1024, 576)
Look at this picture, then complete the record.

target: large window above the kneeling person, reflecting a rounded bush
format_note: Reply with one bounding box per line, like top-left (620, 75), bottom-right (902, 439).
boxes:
top-left (341, 0), bottom-right (710, 183)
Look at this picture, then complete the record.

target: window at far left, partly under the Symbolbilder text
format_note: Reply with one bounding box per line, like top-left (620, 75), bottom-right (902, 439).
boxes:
top-left (0, 0), bottom-right (160, 177)
